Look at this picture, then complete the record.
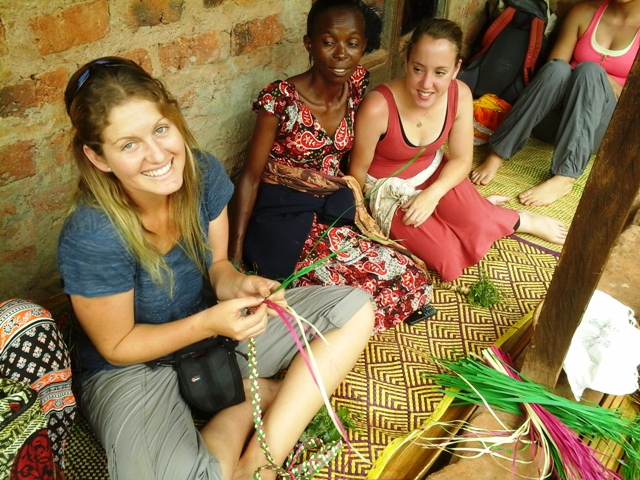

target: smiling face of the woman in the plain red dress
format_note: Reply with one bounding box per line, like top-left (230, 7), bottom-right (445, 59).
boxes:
top-left (405, 35), bottom-right (461, 108)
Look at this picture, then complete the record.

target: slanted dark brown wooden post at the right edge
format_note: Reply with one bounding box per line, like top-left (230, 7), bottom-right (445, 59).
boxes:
top-left (522, 51), bottom-right (640, 388)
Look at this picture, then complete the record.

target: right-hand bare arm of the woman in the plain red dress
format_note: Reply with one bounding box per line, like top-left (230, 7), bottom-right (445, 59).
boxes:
top-left (401, 79), bottom-right (473, 227)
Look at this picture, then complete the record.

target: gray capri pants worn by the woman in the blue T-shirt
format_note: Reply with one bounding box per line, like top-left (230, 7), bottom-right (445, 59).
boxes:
top-left (82, 286), bottom-right (371, 480)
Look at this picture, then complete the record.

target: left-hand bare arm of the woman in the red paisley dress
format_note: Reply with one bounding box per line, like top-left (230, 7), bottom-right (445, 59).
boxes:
top-left (230, 110), bottom-right (279, 265)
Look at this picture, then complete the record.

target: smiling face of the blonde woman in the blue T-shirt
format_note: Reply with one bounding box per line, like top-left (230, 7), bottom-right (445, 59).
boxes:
top-left (84, 98), bottom-right (186, 206)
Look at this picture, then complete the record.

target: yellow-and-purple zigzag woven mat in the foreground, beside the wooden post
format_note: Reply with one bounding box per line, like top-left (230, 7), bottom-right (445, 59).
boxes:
top-left (317, 237), bottom-right (557, 480)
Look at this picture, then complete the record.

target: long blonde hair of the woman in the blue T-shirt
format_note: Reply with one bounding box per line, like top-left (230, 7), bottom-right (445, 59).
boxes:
top-left (65, 57), bottom-right (208, 292)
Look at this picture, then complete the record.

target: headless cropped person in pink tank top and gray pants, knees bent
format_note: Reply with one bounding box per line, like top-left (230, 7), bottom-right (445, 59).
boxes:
top-left (471, 0), bottom-right (640, 206)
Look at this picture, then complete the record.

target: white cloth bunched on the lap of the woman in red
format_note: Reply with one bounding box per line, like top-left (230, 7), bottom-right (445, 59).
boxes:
top-left (364, 148), bottom-right (444, 236)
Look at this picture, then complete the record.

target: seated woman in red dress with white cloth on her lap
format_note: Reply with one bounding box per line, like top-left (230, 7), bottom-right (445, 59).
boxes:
top-left (349, 18), bottom-right (566, 282)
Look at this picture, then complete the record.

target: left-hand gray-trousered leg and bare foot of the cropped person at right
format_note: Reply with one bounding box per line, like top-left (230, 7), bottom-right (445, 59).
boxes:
top-left (471, 60), bottom-right (571, 185)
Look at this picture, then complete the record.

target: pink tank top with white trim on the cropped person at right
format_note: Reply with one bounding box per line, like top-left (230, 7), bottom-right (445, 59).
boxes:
top-left (571, 0), bottom-right (640, 85)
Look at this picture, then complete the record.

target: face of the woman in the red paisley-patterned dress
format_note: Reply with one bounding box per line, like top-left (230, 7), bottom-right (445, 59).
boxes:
top-left (304, 10), bottom-right (367, 83)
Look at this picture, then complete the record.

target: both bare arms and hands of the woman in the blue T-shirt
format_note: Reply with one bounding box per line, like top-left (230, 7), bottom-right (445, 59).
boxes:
top-left (71, 204), bottom-right (284, 366)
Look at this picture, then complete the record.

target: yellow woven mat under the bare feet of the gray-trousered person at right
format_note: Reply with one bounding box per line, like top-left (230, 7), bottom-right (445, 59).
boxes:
top-left (473, 137), bottom-right (593, 252)
